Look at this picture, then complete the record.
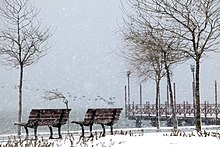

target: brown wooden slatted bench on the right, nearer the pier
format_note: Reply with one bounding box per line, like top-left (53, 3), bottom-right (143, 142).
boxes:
top-left (71, 108), bottom-right (122, 137)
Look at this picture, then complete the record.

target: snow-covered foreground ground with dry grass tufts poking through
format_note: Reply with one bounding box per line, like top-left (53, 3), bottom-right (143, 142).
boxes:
top-left (0, 126), bottom-right (220, 147)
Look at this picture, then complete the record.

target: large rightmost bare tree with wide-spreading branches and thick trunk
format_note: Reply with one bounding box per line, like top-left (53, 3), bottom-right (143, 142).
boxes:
top-left (121, 0), bottom-right (220, 131)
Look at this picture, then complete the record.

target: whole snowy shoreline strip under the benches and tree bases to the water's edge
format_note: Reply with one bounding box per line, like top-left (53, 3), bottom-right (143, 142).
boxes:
top-left (0, 126), bottom-right (220, 147)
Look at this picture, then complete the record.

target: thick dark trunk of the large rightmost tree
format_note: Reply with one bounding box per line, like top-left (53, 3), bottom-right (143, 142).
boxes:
top-left (195, 58), bottom-right (201, 131)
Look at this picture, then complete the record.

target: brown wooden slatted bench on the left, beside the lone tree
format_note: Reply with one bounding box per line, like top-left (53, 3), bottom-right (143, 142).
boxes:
top-left (15, 109), bottom-right (71, 139)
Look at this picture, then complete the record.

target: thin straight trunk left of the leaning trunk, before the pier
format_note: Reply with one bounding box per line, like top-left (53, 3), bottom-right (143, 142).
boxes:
top-left (156, 78), bottom-right (160, 130)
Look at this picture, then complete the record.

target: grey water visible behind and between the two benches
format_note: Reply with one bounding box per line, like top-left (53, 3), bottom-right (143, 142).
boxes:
top-left (0, 109), bottom-right (141, 135)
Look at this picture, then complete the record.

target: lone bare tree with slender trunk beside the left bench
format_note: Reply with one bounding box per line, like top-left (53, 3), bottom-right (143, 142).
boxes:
top-left (0, 0), bottom-right (51, 135)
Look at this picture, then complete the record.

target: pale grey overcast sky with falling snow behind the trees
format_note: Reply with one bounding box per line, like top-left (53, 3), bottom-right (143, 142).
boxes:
top-left (0, 0), bottom-right (220, 112)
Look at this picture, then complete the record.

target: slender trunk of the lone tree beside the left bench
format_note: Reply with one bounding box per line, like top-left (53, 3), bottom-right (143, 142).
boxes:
top-left (18, 64), bottom-right (24, 135)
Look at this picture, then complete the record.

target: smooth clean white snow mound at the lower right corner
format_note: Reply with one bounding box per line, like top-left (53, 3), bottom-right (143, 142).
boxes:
top-left (91, 133), bottom-right (220, 147)
